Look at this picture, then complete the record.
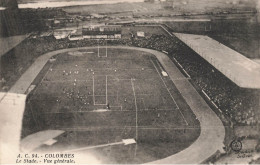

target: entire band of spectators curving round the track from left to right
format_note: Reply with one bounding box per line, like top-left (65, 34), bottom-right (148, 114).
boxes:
top-left (1, 31), bottom-right (259, 125)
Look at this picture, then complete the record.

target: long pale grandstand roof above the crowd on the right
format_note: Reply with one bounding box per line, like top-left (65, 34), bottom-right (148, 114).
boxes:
top-left (173, 33), bottom-right (260, 89)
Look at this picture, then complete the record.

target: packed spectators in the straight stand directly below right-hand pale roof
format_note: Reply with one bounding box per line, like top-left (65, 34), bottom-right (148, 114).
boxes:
top-left (168, 37), bottom-right (259, 125)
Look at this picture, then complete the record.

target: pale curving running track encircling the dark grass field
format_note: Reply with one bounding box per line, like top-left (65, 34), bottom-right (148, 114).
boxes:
top-left (9, 46), bottom-right (225, 164)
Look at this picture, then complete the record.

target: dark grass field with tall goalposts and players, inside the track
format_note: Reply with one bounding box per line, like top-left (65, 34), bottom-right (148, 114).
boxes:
top-left (22, 48), bottom-right (200, 163)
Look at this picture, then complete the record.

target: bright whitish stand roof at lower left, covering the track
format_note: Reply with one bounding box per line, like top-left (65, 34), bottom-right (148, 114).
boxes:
top-left (0, 92), bottom-right (26, 164)
